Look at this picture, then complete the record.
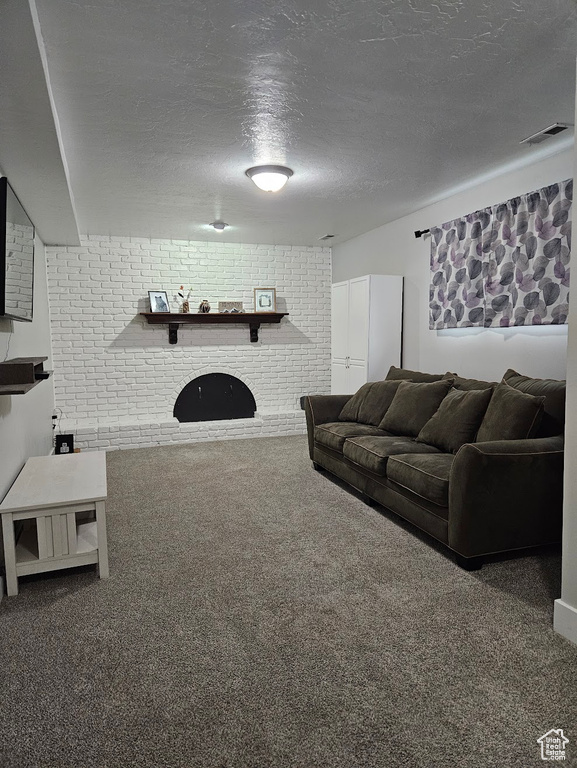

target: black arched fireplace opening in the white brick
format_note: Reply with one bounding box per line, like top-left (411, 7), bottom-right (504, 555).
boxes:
top-left (173, 373), bottom-right (256, 422)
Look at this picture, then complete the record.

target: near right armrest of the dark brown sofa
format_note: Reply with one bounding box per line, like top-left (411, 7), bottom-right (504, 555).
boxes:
top-left (449, 436), bottom-right (563, 557)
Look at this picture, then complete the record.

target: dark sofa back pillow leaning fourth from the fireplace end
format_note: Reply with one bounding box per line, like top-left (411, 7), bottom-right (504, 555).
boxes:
top-left (477, 384), bottom-right (545, 443)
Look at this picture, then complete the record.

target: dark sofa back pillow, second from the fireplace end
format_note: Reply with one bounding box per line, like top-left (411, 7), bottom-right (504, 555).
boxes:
top-left (379, 379), bottom-right (451, 437)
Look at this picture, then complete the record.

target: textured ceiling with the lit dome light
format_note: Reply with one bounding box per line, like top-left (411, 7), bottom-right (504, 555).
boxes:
top-left (10, 0), bottom-right (577, 244)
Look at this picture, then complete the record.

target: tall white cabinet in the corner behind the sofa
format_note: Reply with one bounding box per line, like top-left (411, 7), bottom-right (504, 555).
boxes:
top-left (331, 275), bottom-right (403, 395)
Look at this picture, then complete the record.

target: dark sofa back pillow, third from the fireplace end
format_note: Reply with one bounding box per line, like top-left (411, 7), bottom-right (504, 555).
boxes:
top-left (417, 389), bottom-right (492, 453)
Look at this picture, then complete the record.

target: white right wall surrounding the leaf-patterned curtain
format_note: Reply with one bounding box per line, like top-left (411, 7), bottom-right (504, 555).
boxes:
top-left (333, 149), bottom-right (573, 380)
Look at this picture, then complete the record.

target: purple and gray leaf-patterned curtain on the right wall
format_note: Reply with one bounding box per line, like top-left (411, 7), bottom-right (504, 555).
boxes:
top-left (429, 179), bottom-right (573, 329)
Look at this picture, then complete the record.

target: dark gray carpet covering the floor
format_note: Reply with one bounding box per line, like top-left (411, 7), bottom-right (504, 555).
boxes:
top-left (0, 437), bottom-right (577, 768)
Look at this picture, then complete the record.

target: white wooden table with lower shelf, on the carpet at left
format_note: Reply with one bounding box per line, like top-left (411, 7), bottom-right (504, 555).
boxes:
top-left (0, 452), bottom-right (108, 596)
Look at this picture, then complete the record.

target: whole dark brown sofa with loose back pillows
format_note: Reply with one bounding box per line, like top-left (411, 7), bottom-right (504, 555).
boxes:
top-left (305, 368), bottom-right (565, 570)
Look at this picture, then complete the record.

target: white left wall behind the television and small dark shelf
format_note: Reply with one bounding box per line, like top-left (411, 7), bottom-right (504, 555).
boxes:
top-left (0, 238), bottom-right (54, 499)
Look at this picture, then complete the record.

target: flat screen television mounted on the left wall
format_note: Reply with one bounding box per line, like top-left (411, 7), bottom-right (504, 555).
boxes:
top-left (0, 176), bottom-right (34, 321)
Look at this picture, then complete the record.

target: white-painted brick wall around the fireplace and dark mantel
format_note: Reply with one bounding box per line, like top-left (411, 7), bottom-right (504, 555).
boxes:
top-left (46, 236), bottom-right (331, 448)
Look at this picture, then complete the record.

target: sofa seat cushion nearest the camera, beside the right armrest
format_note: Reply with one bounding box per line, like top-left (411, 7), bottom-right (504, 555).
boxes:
top-left (387, 453), bottom-right (455, 507)
